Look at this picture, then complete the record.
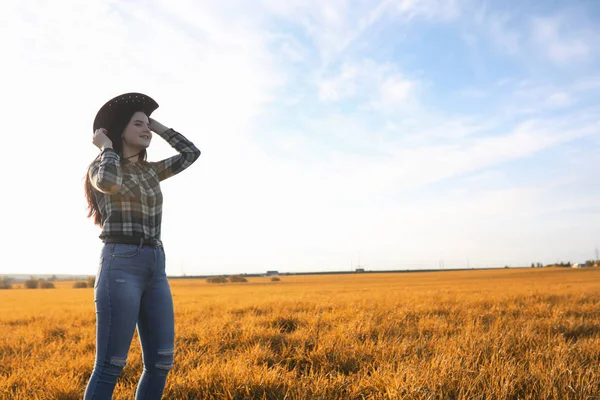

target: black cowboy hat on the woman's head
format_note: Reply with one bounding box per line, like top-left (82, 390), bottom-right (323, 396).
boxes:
top-left (93, 93), bottom-right (158, 132)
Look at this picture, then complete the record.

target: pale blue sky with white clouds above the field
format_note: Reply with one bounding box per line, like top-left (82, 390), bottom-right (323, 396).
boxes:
top-left (0, 0), bottom-right (600, 275)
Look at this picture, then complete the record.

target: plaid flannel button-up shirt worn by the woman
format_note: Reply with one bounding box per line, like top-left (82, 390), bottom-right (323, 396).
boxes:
top-left (88, 129), bottom-right (200, 239)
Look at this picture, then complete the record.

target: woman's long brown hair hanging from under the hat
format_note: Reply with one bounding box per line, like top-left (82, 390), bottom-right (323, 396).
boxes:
top-left (83, 109), bottom-right (147, 227)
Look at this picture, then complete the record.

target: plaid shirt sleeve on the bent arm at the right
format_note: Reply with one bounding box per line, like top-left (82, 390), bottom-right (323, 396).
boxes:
top-left (149, 129), bottom-right (200, 181)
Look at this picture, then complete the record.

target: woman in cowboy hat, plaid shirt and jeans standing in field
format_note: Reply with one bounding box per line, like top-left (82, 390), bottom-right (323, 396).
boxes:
top-left (85, 93), bottom-right (200, 400)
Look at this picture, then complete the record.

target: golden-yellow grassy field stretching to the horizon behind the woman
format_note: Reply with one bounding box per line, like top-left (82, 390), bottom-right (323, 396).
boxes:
top-left (0, 268), bottom-right (600, 400)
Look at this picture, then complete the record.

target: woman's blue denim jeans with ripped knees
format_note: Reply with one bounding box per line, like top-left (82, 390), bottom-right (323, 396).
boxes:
top-left (84, 243), bottom-right (175, 400)
